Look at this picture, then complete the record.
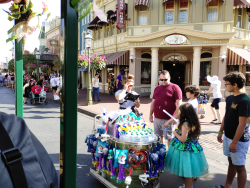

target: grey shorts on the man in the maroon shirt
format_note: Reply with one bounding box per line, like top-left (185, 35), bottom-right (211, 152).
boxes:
top-left (154, 118), bottom-right (174, 140)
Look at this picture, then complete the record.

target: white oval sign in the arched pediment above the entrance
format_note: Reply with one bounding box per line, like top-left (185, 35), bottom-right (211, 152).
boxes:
top-left (161, 34), bottom-right (191, 45)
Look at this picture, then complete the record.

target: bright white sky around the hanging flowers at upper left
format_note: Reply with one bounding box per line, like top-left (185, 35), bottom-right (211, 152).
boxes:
top-left (0, 0), bottom-right (61, 62)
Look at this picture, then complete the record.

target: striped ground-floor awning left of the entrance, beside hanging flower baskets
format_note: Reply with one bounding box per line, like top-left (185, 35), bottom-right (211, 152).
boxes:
top-left (102, 51), bottom-right (129, 65)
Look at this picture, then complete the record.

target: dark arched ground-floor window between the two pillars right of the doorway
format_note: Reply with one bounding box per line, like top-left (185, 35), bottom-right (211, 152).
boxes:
top-left (199, 61), bottom-right (211, 86)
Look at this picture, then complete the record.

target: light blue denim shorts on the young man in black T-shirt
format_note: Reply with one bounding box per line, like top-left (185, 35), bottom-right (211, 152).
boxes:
top-left (223, 135), bottom-right (249, 166)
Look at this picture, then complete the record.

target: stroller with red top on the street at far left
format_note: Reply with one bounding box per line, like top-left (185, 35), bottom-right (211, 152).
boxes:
top-left (30, 85), bottom-right (48, 105)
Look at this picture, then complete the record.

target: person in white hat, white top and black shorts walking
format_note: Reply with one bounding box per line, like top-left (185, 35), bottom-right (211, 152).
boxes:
top-left (204, 76), bottom-right (222, 125)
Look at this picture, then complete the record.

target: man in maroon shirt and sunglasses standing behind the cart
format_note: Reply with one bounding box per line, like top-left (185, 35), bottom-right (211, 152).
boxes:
top-left (149, 70), bottom-right (182, 146)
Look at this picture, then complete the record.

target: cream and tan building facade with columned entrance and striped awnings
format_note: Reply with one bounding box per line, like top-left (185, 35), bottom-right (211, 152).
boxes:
top-left (88, 0), bottom-right (250, 97)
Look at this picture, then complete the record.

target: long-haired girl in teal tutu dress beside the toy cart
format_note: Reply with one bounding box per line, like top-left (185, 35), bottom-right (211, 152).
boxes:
top-left (165, 103), bottom-right (208, 188)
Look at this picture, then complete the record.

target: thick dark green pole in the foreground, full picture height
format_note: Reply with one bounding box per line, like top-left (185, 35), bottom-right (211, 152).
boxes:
top-left (59, 0), bottom-right (78, 188)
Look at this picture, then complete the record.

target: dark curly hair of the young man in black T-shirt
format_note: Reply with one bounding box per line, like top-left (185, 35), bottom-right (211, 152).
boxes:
top-left (223, 71), bottom-right (246, 89)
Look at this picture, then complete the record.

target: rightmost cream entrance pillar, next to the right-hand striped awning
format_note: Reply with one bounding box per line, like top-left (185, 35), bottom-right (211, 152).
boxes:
top-left (218, 46), bottom-right (227, 97)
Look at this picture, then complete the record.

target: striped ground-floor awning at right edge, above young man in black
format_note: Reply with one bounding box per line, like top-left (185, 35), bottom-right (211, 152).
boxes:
top-left (227, 48), bottom-right (250, 65)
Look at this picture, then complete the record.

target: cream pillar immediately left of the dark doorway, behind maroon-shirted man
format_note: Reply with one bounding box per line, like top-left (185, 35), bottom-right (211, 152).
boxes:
top-left (150, 48), bottom-right (159, 98)
